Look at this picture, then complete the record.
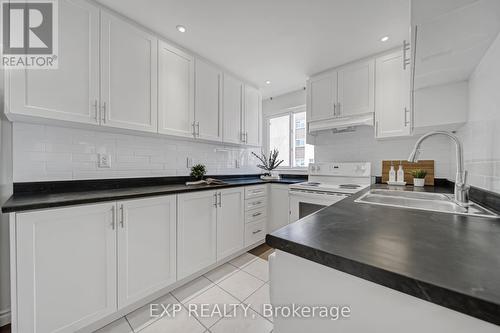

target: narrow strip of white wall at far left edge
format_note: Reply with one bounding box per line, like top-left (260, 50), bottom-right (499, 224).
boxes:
top-left (0, 70), bottom-right (12, 326)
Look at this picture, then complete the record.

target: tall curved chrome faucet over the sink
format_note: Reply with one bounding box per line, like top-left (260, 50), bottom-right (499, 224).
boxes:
top-left (408, 131), bottom-right (469, 206)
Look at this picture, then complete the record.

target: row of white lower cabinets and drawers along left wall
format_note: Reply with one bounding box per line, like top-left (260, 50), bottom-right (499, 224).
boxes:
top-left (11, 185), bottom-right (267, 333)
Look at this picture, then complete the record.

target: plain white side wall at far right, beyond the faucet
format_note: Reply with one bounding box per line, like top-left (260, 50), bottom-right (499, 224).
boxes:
top-left (458, 35), bottom-right (500, 193)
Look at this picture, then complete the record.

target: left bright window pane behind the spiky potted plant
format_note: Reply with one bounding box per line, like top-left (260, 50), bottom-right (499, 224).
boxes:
top-left (269, 115), bottom-right (290, 167)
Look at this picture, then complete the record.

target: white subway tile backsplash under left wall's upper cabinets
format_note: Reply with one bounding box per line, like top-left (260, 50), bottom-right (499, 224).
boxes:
top-left (13, 123), bottom-right (260, 182)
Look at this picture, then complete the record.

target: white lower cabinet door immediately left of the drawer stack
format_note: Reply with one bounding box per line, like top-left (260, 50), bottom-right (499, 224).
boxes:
top-left (217, 187), bottom-right (245, 260)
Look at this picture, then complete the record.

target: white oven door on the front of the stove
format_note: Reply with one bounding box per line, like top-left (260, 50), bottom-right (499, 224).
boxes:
top-left (289, 189), bottom-right (347, 223)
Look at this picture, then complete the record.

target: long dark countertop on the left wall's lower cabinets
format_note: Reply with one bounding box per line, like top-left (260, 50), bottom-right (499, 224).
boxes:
top-left (2, 176), bottom-right (307, 213)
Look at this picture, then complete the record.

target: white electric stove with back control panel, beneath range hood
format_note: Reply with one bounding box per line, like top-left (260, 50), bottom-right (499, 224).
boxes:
top-left (289, 162), bottom-right (371, 223)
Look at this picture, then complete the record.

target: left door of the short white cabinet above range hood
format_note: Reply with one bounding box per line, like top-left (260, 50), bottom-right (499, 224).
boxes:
top-left (307, 72), bottom-right (337, 121)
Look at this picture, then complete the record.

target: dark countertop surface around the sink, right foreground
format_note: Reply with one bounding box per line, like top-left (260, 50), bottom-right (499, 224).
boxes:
top-left (266, 185), bottom-right (500, 325)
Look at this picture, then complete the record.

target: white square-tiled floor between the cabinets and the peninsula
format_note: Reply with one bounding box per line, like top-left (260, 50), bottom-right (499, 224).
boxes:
top-left (97, 253), bottom-right (273, 333)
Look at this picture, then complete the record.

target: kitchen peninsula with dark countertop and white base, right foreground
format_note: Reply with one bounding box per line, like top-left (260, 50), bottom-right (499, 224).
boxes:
top-left (266, 185), bottom-right (500, 333)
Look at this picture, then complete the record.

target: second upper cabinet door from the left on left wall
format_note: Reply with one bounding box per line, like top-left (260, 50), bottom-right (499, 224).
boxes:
top-left (101, 11), bottom-right (158, 132)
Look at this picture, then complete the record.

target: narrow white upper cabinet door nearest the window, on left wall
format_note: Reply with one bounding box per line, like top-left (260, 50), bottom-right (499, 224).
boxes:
top-left (244, 86), bottom-right (262, 146)
